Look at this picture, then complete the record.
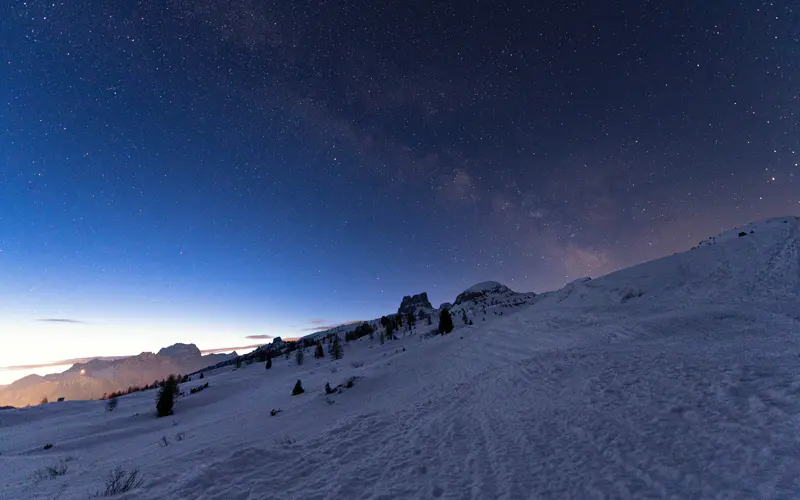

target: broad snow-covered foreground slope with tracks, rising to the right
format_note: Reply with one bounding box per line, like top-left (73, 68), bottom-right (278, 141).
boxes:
top-left (0, 217), bottom-right (800, 500)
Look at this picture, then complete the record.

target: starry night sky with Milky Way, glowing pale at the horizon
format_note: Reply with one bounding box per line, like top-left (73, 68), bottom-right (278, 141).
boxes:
top-left (0, 0), bottom-right (800, 383)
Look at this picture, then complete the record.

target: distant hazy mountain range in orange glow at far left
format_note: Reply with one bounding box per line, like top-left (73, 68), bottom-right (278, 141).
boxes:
top-left (0, 344), bottom-right (230, 406)
